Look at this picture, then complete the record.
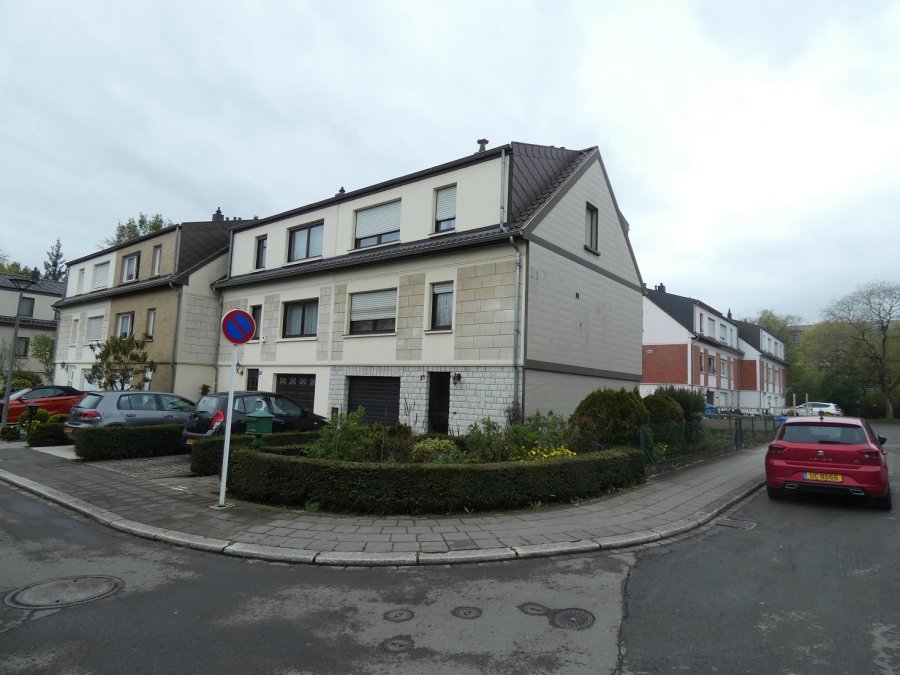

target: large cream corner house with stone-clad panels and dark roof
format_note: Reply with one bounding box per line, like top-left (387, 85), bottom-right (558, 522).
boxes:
top-left (215, 143), bottom-right (643, 432)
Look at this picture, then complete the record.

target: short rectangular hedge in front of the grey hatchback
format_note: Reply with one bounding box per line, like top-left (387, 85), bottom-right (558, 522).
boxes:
top-left (75, 424), bottom-right (186, 460)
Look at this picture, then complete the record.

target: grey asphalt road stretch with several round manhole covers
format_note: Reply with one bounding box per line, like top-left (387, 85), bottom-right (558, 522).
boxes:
top-left (0, 486), bottom-right (632, 675)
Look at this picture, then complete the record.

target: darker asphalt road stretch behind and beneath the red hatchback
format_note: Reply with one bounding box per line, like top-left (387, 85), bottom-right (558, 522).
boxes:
top-left (621, 427), bottom-right (900, 675)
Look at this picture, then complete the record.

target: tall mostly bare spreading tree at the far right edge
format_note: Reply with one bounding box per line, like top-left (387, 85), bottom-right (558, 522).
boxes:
top-left (825, 281), bottom-right (900, 419)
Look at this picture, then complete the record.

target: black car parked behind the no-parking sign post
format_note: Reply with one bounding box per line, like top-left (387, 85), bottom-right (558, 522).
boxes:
top-left (181, 391), bottom-right (328, 445)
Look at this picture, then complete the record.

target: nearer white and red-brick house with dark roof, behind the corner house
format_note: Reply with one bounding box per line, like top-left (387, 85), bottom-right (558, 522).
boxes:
top-left (641, 284), bottom-right (744, 408)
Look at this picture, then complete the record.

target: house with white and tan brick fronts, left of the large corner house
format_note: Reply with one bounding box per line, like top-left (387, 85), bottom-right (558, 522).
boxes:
top-left (55, 212), bottom-right (235, 400)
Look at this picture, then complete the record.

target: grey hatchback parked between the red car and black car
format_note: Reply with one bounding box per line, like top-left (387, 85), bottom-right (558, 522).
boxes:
top-left (64, 390), bottom-right (194, 435)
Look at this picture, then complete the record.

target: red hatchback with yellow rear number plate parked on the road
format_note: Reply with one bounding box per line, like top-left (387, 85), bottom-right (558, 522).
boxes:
top-left (766, 417), bottom-right (891, 511)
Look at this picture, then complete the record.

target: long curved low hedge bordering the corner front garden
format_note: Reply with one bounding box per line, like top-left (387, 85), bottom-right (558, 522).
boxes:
top-left (228, 447), bottom-right (644, 514)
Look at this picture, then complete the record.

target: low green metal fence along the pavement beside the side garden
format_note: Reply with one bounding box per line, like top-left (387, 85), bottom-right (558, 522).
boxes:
top-left (641, 415), bottom-right (778, 464)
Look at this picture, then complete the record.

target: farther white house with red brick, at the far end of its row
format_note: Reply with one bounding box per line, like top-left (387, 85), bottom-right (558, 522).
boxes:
top-left (735, 321), bottom-right (787, 414)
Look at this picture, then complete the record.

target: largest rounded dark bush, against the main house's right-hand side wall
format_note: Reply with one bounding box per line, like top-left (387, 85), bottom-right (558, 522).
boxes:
top-left (571, 387), bottom-right (650, 451)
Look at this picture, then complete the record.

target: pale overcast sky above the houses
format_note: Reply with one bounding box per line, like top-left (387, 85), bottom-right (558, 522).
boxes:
top-left (0, 0), bottom-right (900, 322)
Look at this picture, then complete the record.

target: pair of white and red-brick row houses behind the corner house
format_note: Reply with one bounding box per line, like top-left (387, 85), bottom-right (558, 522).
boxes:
top-left (641, 284), bottom-right (787, 412)
